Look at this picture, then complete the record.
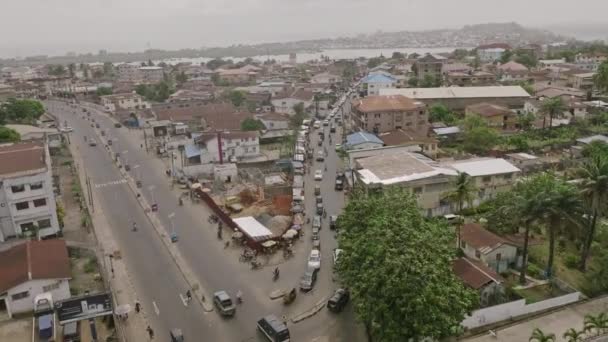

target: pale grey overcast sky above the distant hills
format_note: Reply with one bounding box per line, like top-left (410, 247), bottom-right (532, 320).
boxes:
top-left (0, 0), bottom-right (608, 57)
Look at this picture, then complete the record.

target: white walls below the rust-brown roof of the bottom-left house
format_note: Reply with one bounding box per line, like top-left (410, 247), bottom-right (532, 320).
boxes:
top-left (5, 279), bottom-right (70, 316)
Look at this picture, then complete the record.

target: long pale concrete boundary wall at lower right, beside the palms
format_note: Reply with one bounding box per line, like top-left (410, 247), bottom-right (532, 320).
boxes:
top-left (460, 292), bottom-right (581, 329)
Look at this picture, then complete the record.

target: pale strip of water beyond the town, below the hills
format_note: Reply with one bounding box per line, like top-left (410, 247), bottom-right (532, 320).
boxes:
top-left (154, 47), bottom-right (471, 65)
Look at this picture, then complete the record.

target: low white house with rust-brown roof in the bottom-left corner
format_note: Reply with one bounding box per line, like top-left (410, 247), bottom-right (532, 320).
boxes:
top-left (0, 240), bottom-right (71, 317)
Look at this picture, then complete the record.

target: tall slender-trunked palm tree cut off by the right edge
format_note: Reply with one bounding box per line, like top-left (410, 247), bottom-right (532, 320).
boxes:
top-left (579, 154), bottom-right (608, 271)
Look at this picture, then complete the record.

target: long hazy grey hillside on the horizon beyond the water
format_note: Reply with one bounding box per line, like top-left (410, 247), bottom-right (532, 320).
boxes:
top-left (0, 23), bottom-right (568, 65)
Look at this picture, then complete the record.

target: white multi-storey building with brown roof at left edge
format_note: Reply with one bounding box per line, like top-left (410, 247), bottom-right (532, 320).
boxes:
top-left (0, 141), bottom-right (60, 241)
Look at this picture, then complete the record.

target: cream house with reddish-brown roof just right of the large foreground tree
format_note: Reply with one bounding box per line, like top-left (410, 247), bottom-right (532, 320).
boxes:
top-left (459, 223), bottom-right (519, 273)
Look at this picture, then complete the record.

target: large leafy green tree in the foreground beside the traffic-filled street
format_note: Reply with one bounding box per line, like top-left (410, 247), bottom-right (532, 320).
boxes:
top-left (337, 188), bottom-right (478, 342)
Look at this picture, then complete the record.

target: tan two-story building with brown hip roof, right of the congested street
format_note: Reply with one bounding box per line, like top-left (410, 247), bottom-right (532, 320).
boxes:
top-left (352, 95), bottom-right (428, 134)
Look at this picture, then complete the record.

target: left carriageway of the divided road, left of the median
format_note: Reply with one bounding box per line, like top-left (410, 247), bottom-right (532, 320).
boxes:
top-left (49, 106), bottom-right (222, 340)
